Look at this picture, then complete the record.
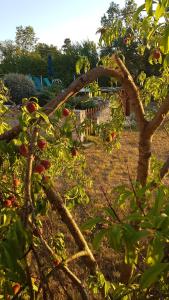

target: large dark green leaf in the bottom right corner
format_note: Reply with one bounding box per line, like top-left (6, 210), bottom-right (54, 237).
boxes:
top-left (140, 263), bottom-right (169, 289)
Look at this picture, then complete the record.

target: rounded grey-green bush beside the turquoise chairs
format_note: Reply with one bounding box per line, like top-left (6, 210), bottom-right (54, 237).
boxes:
top-left (4, 73), bottom-right (36, 104)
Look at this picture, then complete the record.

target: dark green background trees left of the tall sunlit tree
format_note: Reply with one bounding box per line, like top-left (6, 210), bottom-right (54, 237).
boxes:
top-left (0, 26), bottom-right (98, 86)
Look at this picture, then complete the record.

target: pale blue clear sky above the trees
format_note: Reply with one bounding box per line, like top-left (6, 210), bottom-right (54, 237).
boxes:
top-left (0, 0), bottom-right (142, 48)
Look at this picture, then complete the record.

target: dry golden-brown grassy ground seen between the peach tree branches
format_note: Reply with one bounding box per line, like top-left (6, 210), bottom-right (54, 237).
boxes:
top-left (46, 130), bottom-right (169, 300)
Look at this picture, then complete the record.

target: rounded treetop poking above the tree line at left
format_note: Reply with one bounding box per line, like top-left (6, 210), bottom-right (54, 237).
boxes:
top-left (15, 26), bottom-right (38, 51)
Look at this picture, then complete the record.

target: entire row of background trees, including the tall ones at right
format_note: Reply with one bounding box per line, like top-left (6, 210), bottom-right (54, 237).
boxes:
top-left (0, 0), bottom-right (160, 87)
